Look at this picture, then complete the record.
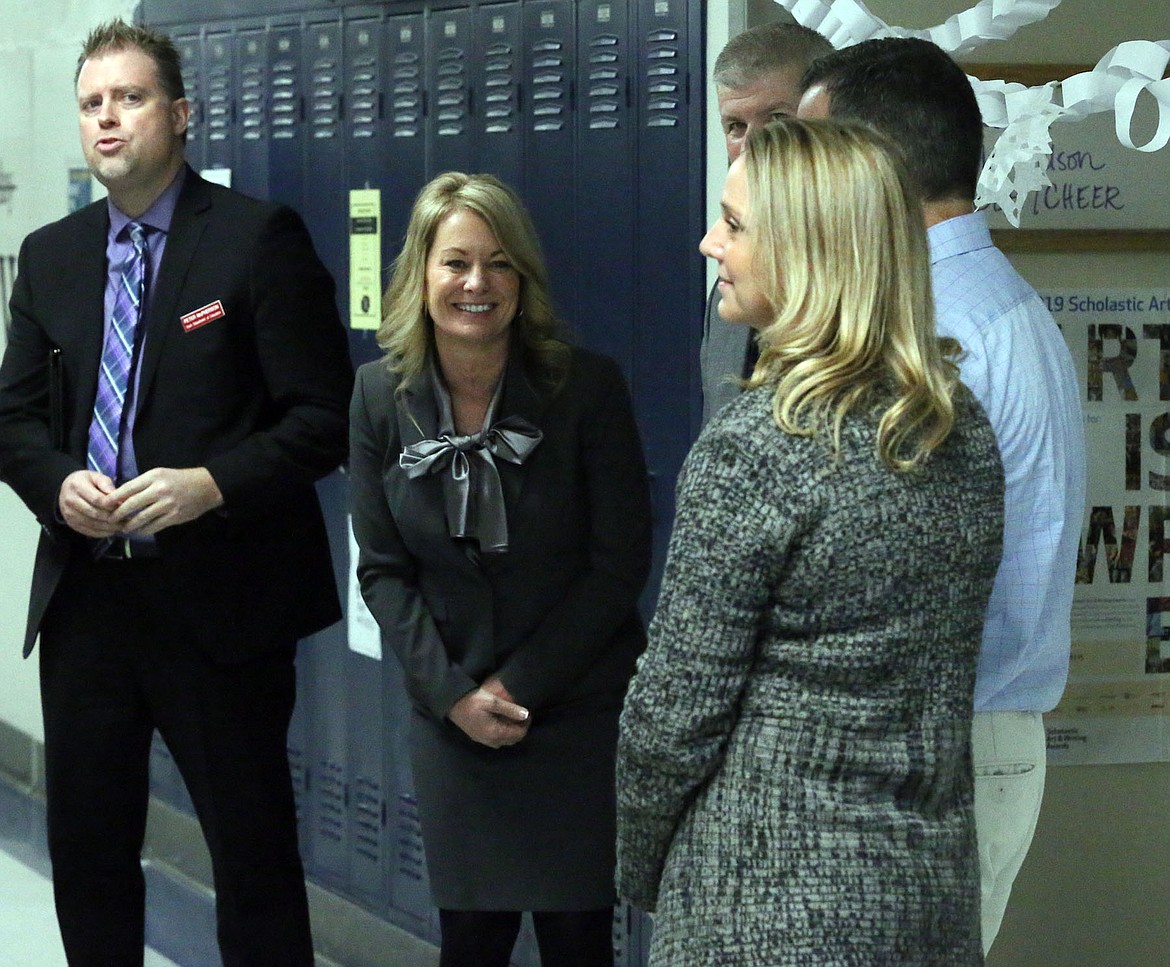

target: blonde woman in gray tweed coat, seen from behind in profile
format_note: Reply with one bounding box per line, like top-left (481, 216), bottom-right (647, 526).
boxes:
top-left (618, 121), bottom-right (1003, 967)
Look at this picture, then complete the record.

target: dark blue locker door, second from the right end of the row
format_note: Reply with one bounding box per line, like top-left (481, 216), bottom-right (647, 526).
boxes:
top-left (574, 0), bottom-right (638, 379)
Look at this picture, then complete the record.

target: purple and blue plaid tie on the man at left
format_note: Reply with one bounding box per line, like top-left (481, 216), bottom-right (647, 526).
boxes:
top-left (87, 221), bottom-right (146, 481)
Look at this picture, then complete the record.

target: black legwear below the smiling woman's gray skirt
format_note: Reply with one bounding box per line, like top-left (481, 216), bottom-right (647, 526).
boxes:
top-left (439, 906), bottom-right (613, 967)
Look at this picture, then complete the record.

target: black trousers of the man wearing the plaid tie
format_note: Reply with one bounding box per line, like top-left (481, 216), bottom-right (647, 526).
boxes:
top-left (40, 550), bottom-right (314, 967)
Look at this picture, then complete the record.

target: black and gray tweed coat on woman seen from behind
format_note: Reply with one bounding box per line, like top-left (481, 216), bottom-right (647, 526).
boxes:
top-left (618, 389), bottom-right (1003, 967)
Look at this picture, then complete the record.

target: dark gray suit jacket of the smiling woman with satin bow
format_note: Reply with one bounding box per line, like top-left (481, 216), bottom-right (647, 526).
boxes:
top-left (350, 347), bottom-right (651, 719)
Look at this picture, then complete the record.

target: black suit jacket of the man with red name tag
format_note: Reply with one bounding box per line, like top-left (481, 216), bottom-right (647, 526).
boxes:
top-left (0, 169), bottom-right (352, 661)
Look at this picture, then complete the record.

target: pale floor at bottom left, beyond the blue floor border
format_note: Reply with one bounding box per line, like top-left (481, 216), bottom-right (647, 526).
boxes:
top-left (0, 850), bottom-right (177, 967)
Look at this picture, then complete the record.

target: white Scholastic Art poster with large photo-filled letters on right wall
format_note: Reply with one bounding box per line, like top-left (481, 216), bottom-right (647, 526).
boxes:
top-left (1042, 288), bottom-right (1170, 764)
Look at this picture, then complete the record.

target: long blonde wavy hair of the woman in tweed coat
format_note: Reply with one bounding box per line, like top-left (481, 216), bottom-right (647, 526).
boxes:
top-left (744, 119), bottom-right (958, 471)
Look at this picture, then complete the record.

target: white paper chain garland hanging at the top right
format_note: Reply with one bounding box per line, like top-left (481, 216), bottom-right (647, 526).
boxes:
top-left (776, 0), bottom-right (1170, 227)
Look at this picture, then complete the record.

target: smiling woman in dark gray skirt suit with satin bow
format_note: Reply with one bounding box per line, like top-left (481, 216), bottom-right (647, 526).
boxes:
top-left (350, 173), bottom-right (651, 967)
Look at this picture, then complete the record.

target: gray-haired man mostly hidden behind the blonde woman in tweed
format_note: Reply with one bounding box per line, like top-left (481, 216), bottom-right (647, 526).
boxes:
top-left (698, 23), bottom-right (833, 424)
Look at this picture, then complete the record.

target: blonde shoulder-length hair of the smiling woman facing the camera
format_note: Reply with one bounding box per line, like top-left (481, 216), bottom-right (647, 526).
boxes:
top-left (377, 171), bottom-right (569, 391)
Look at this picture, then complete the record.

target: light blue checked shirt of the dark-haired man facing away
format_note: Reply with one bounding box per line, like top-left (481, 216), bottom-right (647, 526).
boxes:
top-left (928, 212), bottom-right (1086, 712)
